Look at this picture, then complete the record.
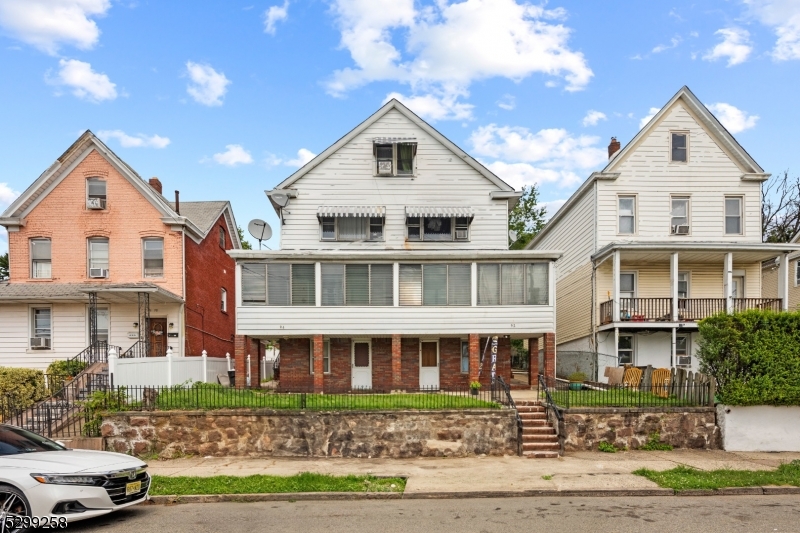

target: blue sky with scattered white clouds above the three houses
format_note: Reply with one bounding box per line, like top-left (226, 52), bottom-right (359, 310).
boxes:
top-left (0, 0), bottom-right (800, 253)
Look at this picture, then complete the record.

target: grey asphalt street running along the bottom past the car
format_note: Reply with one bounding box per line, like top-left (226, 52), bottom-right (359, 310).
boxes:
top-left (69, 495), bottom-right (800, 533)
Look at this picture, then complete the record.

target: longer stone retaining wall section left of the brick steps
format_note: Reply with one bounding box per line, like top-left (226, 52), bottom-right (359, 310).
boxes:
top-left (101, 409), bottom-right (517, 459)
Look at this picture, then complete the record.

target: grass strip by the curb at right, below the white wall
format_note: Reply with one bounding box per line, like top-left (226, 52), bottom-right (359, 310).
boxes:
top-left (633, 459), bottom-right (800, 490)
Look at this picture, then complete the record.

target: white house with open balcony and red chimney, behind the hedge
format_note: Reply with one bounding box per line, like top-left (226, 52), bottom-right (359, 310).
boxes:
top-left (528, 87), bottom-right (800, 379)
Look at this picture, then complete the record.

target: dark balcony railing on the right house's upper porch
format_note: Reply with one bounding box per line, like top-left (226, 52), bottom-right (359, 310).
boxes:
top-left (600, 298), bottom-right (782, 324)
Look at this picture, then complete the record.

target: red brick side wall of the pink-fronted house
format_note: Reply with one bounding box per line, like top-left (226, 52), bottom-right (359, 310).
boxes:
top-left (185, 216), bottom-right (236, 357)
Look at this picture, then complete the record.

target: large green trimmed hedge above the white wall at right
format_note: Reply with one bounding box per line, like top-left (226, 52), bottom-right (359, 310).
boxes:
top-left (697, 310), bottom-right (800, 405)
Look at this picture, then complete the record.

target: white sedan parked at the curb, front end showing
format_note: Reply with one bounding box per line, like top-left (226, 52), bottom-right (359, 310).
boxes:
top-left (0, 424), bottom-right (150, 532)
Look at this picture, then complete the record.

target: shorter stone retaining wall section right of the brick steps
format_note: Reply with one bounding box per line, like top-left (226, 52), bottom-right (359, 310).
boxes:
top-left (560, 407), bottom-right (721, 452)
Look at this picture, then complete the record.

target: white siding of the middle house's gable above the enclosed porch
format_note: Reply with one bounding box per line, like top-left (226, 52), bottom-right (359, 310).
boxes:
top-left (281, 110), bottom-right (508, 250)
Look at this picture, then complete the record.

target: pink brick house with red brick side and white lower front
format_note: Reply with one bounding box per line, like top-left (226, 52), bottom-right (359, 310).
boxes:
top-left (0, 131), bottom-right (241, 369)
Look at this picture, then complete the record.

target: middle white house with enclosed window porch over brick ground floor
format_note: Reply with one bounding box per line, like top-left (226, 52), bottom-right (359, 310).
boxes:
top-left (230, 100), bottom-right (559, 392)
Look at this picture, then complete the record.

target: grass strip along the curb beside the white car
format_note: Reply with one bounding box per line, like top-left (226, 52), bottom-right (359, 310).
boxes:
top-left (150, 472), bottom-right (406, 496)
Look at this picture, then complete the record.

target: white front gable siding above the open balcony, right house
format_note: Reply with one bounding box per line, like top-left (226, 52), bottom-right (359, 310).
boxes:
top-left (597, 101), bottom-right (761, 248)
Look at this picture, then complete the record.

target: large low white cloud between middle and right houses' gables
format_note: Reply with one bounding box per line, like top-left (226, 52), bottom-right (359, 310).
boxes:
top-left (470, 124), bottom-right (607, 188)
